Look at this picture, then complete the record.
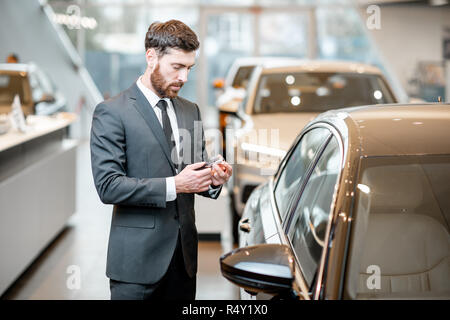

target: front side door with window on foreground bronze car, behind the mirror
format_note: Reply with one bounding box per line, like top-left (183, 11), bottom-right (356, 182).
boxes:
top-left (284, 131), bottom-right (343, 297)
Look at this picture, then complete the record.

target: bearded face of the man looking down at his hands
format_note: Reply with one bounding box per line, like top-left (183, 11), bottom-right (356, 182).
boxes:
top-left (150, 49), bottom-right (195, 98)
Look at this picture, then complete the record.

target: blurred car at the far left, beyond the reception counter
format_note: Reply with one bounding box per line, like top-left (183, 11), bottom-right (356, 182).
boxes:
top-left (0, 63), bottom-right (66, 115)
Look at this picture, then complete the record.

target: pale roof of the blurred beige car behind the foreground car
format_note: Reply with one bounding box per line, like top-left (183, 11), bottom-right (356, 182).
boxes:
top-left (262, 60), bottom-right (382, 75)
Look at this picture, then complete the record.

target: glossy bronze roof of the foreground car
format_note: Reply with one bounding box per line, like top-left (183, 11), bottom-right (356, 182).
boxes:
top-left (310, 103), bottom-right (450, 157)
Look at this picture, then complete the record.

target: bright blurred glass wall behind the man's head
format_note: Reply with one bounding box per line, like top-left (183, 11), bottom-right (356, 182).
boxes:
top-left (49, 0), bottom-right (396, 107)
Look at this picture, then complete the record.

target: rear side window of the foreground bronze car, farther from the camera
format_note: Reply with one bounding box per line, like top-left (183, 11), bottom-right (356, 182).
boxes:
top-left (275, 128), bottom-right (330, 221)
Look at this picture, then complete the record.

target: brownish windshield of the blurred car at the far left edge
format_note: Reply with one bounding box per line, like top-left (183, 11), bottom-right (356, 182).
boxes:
top-left (0, 73), bottom-right (30, 105)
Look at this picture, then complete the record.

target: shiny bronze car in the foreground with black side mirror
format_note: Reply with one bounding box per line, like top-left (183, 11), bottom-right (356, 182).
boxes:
top-left (221, 104), bottom-right (450, 299)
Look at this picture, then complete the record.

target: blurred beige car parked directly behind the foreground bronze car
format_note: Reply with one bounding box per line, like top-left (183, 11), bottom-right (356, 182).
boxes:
top-left (227, 61), bottom-right (398, 242)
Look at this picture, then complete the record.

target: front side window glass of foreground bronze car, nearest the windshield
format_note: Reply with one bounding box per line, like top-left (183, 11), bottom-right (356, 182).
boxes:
top-left (288, 137), bottom-right (341, 286)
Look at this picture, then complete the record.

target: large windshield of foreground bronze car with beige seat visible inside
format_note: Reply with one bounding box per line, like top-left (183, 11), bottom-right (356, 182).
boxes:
top-left (352, 155), bottom-right (450, 299)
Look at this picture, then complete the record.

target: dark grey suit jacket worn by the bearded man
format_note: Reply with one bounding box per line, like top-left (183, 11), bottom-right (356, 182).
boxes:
top-left (91, 83), bottom-right (220, 284)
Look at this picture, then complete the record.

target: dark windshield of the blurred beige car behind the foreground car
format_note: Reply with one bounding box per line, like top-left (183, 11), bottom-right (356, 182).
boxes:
top-left (253, 72), bottom-right (396, 113)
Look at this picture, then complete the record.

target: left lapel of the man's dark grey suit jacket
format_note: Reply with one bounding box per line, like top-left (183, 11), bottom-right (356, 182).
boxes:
top-left (130, 83), bottom-right (178, 173)
